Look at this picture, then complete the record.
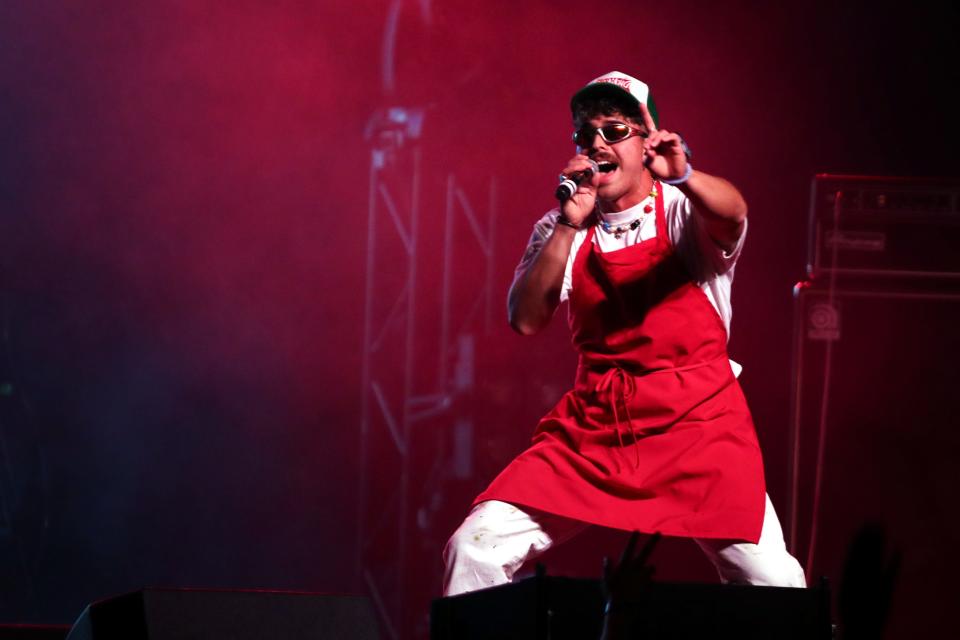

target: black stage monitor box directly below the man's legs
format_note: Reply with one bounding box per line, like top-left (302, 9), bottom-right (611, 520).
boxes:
top-left (430, 576), bottom-right (832, 640)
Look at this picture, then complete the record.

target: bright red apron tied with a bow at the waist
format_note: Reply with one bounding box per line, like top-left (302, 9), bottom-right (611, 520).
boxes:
top-left (474, 187), bottom-right (766, 542)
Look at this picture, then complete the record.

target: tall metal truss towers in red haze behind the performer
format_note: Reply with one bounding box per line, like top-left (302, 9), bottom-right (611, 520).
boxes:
top-left (357, 107), bottom-right (496, 639)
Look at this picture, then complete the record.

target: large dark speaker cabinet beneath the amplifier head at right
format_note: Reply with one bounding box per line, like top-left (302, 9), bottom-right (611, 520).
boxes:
top-left (784, 281), bottom-right (960, 638)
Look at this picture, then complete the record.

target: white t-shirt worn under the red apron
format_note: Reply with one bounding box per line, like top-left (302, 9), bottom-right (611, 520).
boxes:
top-left (514, 184), bottom-right (747, 338)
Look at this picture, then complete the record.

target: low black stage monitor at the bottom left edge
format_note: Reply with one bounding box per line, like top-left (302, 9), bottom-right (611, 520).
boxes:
top-left (67, 589), bottom-right (380, 640)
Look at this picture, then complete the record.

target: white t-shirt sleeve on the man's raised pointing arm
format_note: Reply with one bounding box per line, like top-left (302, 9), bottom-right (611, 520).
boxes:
top-left (665, 189), bottom-right (747, 282)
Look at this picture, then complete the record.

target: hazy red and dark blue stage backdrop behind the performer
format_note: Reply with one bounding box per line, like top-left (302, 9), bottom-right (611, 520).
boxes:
top-left (0, 0), bottom-right (960, 636)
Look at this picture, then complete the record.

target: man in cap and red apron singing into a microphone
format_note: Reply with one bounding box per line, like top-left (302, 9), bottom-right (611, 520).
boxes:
top-left (444, 71), bottom-right (806, 595)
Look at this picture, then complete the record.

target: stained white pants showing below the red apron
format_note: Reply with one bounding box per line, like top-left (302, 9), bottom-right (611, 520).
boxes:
top-left (443, 496), bottom-right (807, 596)
